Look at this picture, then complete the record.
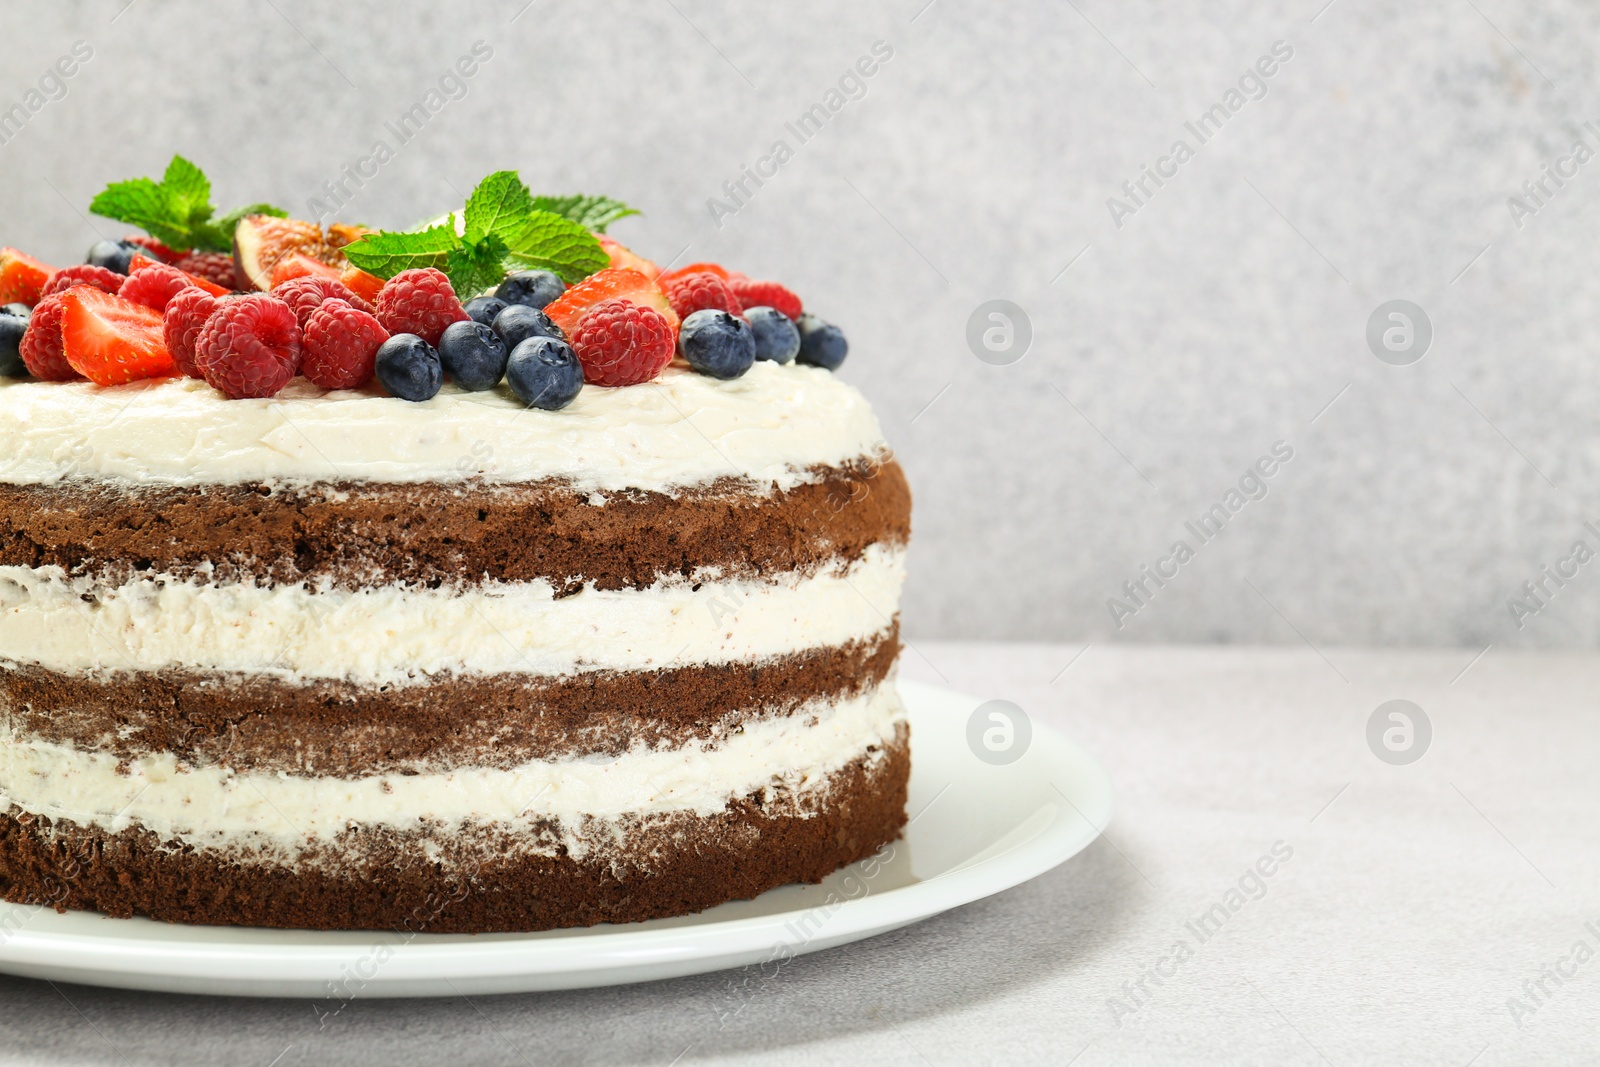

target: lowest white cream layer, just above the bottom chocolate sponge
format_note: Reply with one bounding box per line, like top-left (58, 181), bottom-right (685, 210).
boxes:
top-left (0, 685), bottom-right (904, 856)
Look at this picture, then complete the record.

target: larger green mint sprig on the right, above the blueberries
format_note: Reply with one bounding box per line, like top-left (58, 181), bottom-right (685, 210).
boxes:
top-left (344, 171), bottom-right (617, 299)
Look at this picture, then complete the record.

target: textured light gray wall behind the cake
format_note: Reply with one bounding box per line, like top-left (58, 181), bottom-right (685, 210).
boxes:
top-left (0, 0), bottom-right (1600, 648)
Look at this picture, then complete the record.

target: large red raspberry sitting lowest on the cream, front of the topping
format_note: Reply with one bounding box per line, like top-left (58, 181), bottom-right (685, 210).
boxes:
top-left (195, 293), bottom-right (301, 400)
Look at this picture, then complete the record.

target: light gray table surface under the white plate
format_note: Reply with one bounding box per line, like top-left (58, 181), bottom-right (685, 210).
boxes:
top-left (0, 641), bottom-right (1600, 1067)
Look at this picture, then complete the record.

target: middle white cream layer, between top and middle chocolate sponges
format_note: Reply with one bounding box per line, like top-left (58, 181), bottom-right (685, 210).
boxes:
top-left (0, 545), bottom-right (906, 685)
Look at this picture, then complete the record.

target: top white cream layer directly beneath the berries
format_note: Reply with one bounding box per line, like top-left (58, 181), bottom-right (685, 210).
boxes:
top-left (0, 362), bottom-right (885, 490)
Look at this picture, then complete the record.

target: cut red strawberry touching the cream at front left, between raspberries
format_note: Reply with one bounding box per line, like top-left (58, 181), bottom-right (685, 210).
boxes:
top-left (61, 285), bottom-right (176, 386)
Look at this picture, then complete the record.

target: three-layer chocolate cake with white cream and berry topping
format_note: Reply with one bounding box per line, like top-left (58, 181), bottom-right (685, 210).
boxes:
top-left (0, 160), bottom-right (910, 933)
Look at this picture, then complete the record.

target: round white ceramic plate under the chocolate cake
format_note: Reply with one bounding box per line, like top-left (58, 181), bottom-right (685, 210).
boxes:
top-left (0, 683), bottom-right (1110, 1011)
